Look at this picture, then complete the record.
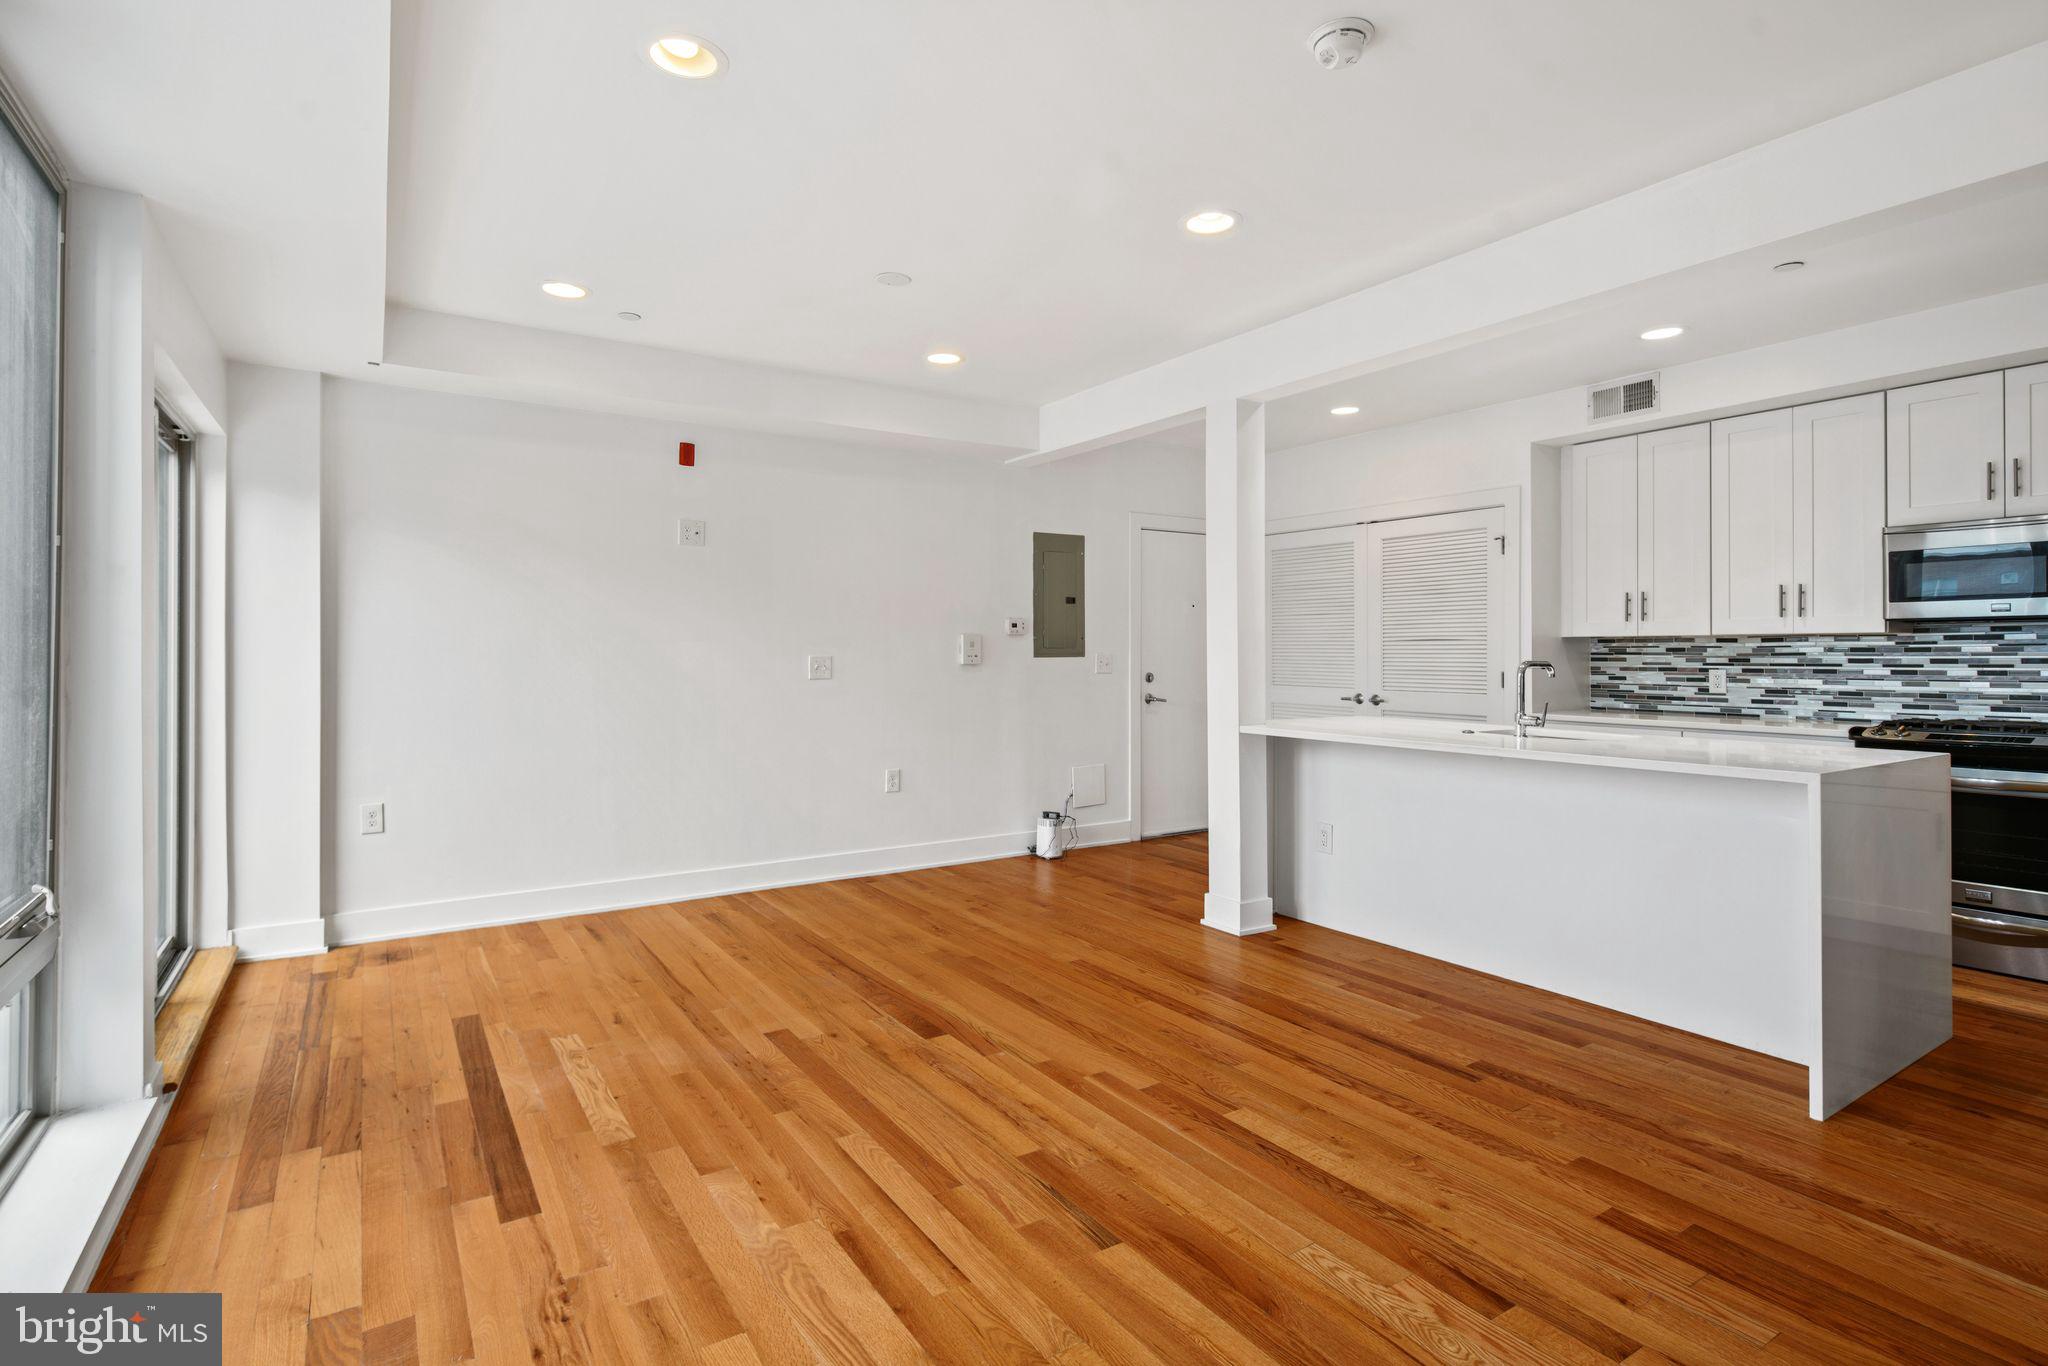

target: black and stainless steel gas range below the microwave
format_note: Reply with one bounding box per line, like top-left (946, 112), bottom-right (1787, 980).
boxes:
top-left (1851, 717), bottom-right (2048, 981)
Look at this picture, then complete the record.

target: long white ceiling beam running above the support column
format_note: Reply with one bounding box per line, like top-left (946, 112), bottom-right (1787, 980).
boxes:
top-left (1012, 43), bottom-right (2048, 465)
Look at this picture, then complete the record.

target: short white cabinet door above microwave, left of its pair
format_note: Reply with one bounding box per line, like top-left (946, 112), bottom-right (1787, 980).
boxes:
top-left (1884, 371), bottom-right (2017, 526)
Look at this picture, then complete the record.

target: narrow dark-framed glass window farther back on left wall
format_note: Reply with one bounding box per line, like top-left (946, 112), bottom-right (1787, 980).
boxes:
top-left (156, 405), bottom-right (193, 1006)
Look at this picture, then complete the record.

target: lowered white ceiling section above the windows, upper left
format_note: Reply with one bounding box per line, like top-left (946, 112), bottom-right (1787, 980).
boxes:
top-left (0, 0), bottom-right (389, 373)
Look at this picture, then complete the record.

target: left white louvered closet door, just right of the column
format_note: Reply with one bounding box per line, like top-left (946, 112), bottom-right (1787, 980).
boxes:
top-left (1266, 526), bottom-right (1372, 721)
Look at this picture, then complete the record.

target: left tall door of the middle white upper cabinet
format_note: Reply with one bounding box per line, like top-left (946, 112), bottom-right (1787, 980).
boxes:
top-left (1714, 408), bottom-right (1798, 635)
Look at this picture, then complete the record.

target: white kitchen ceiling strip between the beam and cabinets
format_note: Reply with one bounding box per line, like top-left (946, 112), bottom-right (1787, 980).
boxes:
top-left (1253, 174), bottom-right (2048, 451)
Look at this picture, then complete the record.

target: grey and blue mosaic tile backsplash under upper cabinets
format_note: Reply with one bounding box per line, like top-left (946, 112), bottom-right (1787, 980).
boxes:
top-left (1589, 623), bottom-right (2048, 721)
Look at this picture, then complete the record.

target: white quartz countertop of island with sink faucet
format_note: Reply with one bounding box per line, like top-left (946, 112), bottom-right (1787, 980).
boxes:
top-left (1241, 717), bottom-right (1948, 784)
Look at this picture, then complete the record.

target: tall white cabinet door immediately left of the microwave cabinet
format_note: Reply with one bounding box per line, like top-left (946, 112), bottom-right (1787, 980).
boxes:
top-left (1792, 387), bottom-right (1884, 633)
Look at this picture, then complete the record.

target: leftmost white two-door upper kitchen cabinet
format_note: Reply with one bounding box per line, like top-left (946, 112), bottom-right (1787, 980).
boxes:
top-left (1563, 424), bottom-right (1712, 637)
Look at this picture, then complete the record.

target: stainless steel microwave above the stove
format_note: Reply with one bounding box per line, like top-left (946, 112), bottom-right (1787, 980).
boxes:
top-left (1884, 520), bottom-right (2048, 621)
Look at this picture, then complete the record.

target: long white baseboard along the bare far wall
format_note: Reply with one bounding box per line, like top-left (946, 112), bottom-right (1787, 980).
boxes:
top-left (313, 821), bottom-right (1130, 958)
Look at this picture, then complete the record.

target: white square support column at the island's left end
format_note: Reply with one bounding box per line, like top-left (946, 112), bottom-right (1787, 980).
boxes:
top-left (1202, 397), bottom-right (1274, 934)
